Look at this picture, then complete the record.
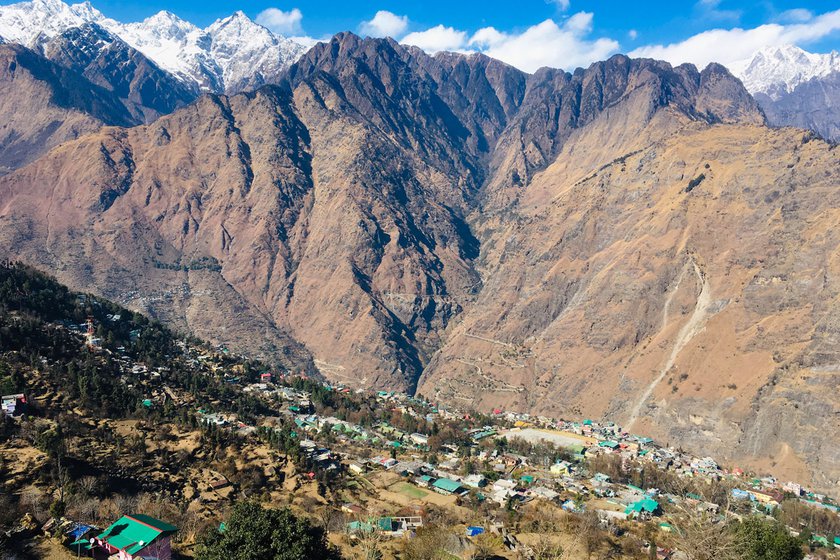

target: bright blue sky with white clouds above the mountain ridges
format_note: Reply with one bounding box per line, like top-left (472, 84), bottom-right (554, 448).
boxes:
top-left (14, 0), bottom-right (840, 71)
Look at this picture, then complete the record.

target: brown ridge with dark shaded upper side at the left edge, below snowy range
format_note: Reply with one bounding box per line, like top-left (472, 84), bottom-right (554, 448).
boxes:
top-left (0, 44), bottom-right (137, 174)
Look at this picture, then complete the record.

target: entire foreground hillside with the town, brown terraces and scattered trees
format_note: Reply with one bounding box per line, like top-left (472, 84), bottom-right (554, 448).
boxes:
top-left (0, 264), bottom-right (840, 560)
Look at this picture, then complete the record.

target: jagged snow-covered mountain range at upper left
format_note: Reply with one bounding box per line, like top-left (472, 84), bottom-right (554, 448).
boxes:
top-left (0, 0), bottom-right (306, 92)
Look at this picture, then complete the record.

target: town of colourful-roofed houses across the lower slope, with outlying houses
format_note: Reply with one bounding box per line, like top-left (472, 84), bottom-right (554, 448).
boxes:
top-left (2, 332), bottom-right (840, 559)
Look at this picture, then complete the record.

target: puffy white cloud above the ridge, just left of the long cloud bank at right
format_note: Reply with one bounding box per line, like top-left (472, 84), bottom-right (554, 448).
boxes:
top-left (474, 12), bottom-right (619, 72)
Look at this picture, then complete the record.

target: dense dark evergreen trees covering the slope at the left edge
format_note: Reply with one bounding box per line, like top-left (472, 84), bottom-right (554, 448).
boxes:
top-left (0, 263), bottom-right (278, 420)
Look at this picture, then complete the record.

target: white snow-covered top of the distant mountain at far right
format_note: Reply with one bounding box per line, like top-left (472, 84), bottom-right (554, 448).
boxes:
top-left (729, 45), bottom-right (840, 99)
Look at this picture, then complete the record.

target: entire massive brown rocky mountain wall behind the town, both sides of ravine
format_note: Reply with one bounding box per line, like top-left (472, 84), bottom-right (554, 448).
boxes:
top-left (0, 34), bottom-right (840, 487)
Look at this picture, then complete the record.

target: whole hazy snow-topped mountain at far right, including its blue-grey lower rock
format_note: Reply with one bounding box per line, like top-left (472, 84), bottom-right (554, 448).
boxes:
top-left (730, 45), bottom-right (840, 141)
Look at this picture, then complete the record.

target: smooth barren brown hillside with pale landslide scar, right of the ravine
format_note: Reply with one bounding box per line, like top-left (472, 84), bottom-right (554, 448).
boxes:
top-left (419, 124), bottom-right (840, 486)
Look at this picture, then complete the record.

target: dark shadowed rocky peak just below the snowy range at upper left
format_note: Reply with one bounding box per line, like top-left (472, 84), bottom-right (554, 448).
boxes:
top-left (42, 23), bottom-right (197, 122)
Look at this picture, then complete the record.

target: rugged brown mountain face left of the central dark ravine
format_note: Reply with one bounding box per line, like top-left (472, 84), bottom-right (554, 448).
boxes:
top-left (3, 36), bottom-right (492, 387)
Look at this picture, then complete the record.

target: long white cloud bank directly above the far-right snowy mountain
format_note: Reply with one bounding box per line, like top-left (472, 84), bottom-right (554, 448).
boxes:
top-left (630, 10), bottom-right (840, 67)
